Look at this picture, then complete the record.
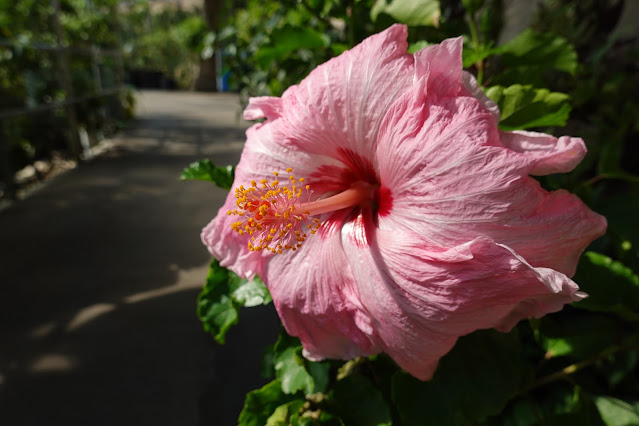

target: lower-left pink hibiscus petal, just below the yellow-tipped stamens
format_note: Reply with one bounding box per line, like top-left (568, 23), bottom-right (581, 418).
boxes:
top-left (260, 212), bottom-right (380, 360)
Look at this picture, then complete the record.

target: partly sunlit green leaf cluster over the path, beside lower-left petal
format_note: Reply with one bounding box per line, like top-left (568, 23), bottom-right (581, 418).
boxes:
top-left (197, 260), bottom-right (272, 344)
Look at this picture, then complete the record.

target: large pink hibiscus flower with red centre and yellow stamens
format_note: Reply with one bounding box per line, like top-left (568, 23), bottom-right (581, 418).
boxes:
top-left (202, 25), bottom-right (606, 380)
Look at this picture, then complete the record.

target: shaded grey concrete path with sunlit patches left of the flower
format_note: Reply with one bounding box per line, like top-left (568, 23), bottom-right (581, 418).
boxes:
top-left (0, 91), bottom-right (279, 426)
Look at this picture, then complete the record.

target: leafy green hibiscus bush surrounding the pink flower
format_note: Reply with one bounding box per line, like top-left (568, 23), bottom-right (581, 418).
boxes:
top-left (183, 0), bottom-right (639, 426)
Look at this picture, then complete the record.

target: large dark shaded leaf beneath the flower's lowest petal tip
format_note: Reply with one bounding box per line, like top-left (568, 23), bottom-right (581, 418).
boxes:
top-left (392, 330), bottom-right (524, 426)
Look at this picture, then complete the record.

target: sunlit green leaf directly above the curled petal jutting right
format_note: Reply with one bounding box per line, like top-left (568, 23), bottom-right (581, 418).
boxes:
top-left (486, 84), bottom-right (571, 130)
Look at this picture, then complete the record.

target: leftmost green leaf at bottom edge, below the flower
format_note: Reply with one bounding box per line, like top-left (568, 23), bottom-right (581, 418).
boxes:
top-left (238, 379), bottom-right (295, 426)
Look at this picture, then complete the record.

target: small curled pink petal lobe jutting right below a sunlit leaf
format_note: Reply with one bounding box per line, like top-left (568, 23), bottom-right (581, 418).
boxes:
top-left (501, 131), bottom-right (586, 176)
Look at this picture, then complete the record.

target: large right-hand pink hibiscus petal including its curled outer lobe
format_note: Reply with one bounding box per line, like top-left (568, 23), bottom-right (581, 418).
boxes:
top-left (377, 90), bottom-right (606, 275)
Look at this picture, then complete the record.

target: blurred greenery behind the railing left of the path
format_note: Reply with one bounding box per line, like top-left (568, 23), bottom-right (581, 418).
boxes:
top-left (0, 0), bottom-right (205, 197)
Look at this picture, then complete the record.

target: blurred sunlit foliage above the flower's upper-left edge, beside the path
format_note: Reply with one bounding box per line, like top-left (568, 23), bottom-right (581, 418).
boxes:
top-left (217, 0), bottom-right (396, 102)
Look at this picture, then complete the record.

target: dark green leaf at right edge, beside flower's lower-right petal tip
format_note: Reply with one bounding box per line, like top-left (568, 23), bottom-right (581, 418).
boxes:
top-left (573, 251), bottom-right (639, 321)
